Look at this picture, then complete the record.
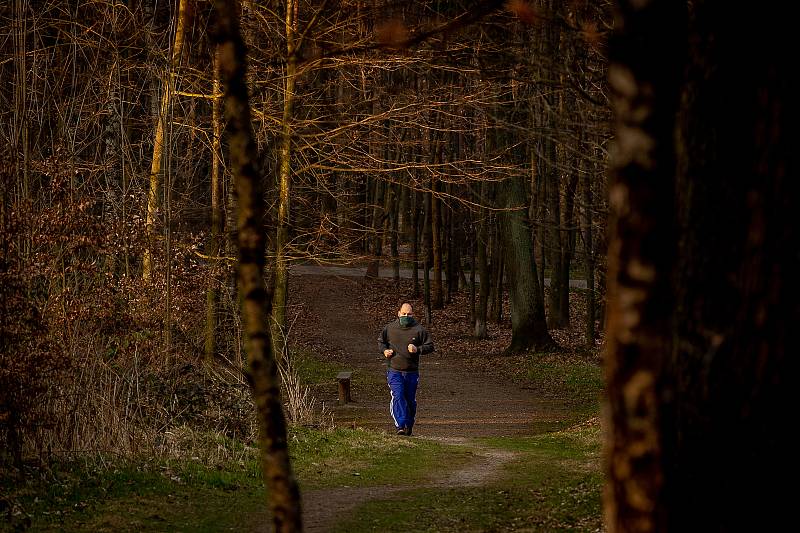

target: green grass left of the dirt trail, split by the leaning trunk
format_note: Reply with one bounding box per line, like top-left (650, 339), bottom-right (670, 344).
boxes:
top-left (0, 428), bottom-right (470, 531)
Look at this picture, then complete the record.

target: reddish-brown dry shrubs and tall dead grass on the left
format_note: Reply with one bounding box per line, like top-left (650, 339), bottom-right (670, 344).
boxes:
top-left (0, 164), bottom-right (328, 466)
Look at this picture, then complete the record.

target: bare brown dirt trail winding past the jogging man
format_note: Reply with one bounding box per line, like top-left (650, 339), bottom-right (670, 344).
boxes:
top-left (253, 271), bottom-right (558, 532)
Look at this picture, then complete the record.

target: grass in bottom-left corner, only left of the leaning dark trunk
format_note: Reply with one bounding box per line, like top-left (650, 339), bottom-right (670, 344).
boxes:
top-left (3, 456), bottom-right (264, 531)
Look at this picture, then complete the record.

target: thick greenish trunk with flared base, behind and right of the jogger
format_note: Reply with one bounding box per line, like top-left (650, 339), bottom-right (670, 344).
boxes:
top-left (500, 177), bottom-right (555, 353)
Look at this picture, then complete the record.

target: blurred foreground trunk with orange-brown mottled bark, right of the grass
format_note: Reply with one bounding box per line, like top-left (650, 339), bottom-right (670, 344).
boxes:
top-left (604, 0), bottom-right (684, 532)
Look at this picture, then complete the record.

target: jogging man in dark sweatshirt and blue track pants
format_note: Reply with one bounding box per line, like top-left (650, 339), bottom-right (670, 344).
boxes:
top-left (378, 303), bottom-right (433, 435)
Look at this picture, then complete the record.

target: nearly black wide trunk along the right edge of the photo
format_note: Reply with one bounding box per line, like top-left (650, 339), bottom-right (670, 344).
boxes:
top-left (670, 1), bottom-right (800, 531)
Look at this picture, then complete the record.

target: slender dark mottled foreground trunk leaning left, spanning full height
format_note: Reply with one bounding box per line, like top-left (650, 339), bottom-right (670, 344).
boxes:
top-left (214, 0), bottom-right (302, 532)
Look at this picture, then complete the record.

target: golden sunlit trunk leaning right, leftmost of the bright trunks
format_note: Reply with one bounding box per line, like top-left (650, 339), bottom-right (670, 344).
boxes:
top-left (142, 0), bottom-right (190, 281)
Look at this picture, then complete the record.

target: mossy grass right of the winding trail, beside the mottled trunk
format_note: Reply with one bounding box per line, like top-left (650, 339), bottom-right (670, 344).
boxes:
top-left (336, 422), bottom-right (602, 532)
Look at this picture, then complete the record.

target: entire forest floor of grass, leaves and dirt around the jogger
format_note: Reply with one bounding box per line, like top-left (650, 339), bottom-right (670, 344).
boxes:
top-left (0, 269), bottom-right (602, 532)
